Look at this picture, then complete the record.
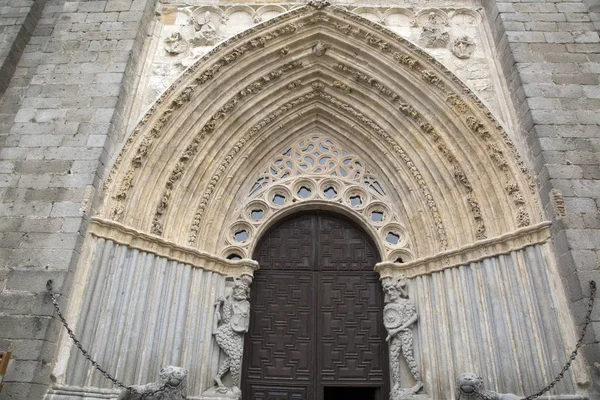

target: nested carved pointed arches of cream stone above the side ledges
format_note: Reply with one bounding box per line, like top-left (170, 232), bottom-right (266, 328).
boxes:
top-left (103, 7), bottom-right (539, 259)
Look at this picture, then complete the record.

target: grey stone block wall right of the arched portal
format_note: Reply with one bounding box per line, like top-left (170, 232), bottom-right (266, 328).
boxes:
top-left (486, 0), bottom-right (600, 390)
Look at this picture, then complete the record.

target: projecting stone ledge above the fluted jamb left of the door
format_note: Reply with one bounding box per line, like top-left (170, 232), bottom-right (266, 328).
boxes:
top-left (88, 218), bottom-right (258, 276)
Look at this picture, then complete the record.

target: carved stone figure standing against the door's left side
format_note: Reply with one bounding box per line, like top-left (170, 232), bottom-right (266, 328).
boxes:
top-left (214, 276), bottom-right (252, 395)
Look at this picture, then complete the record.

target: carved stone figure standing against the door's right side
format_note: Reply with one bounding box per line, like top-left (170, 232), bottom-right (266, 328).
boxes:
top-left (383, 276), bottom-right (423, 400)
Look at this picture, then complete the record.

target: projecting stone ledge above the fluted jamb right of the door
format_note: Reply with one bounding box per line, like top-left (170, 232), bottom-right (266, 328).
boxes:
top-left (375, 222), bottom-right (551, 279)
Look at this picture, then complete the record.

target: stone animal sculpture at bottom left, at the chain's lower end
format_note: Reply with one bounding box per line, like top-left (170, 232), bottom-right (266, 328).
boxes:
top-left (117, 365), bottom-right (188, 400)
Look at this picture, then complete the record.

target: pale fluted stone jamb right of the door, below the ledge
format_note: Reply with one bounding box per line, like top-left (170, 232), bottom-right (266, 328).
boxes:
top-left (410, 245), bottom-right (575, 399)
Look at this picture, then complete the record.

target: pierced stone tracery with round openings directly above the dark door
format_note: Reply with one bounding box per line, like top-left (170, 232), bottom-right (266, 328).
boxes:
top-left (219, 136), bottom-right (414, 262)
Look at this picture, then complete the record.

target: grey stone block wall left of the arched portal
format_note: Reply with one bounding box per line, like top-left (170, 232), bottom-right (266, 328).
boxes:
top-left (0, 0), bottom-right (155, 399)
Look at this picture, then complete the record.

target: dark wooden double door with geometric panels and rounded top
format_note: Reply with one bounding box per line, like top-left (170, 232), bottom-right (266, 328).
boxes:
top-left (242, 213), bottom-right (389, 400)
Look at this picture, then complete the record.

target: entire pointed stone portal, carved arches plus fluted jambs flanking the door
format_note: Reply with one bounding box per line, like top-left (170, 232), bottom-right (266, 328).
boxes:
top-left (55, 6), bottom-right (574, 398)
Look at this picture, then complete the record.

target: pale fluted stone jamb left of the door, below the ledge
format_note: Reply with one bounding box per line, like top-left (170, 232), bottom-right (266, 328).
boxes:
top-left (61, 239), bottom-right (225, 395)
